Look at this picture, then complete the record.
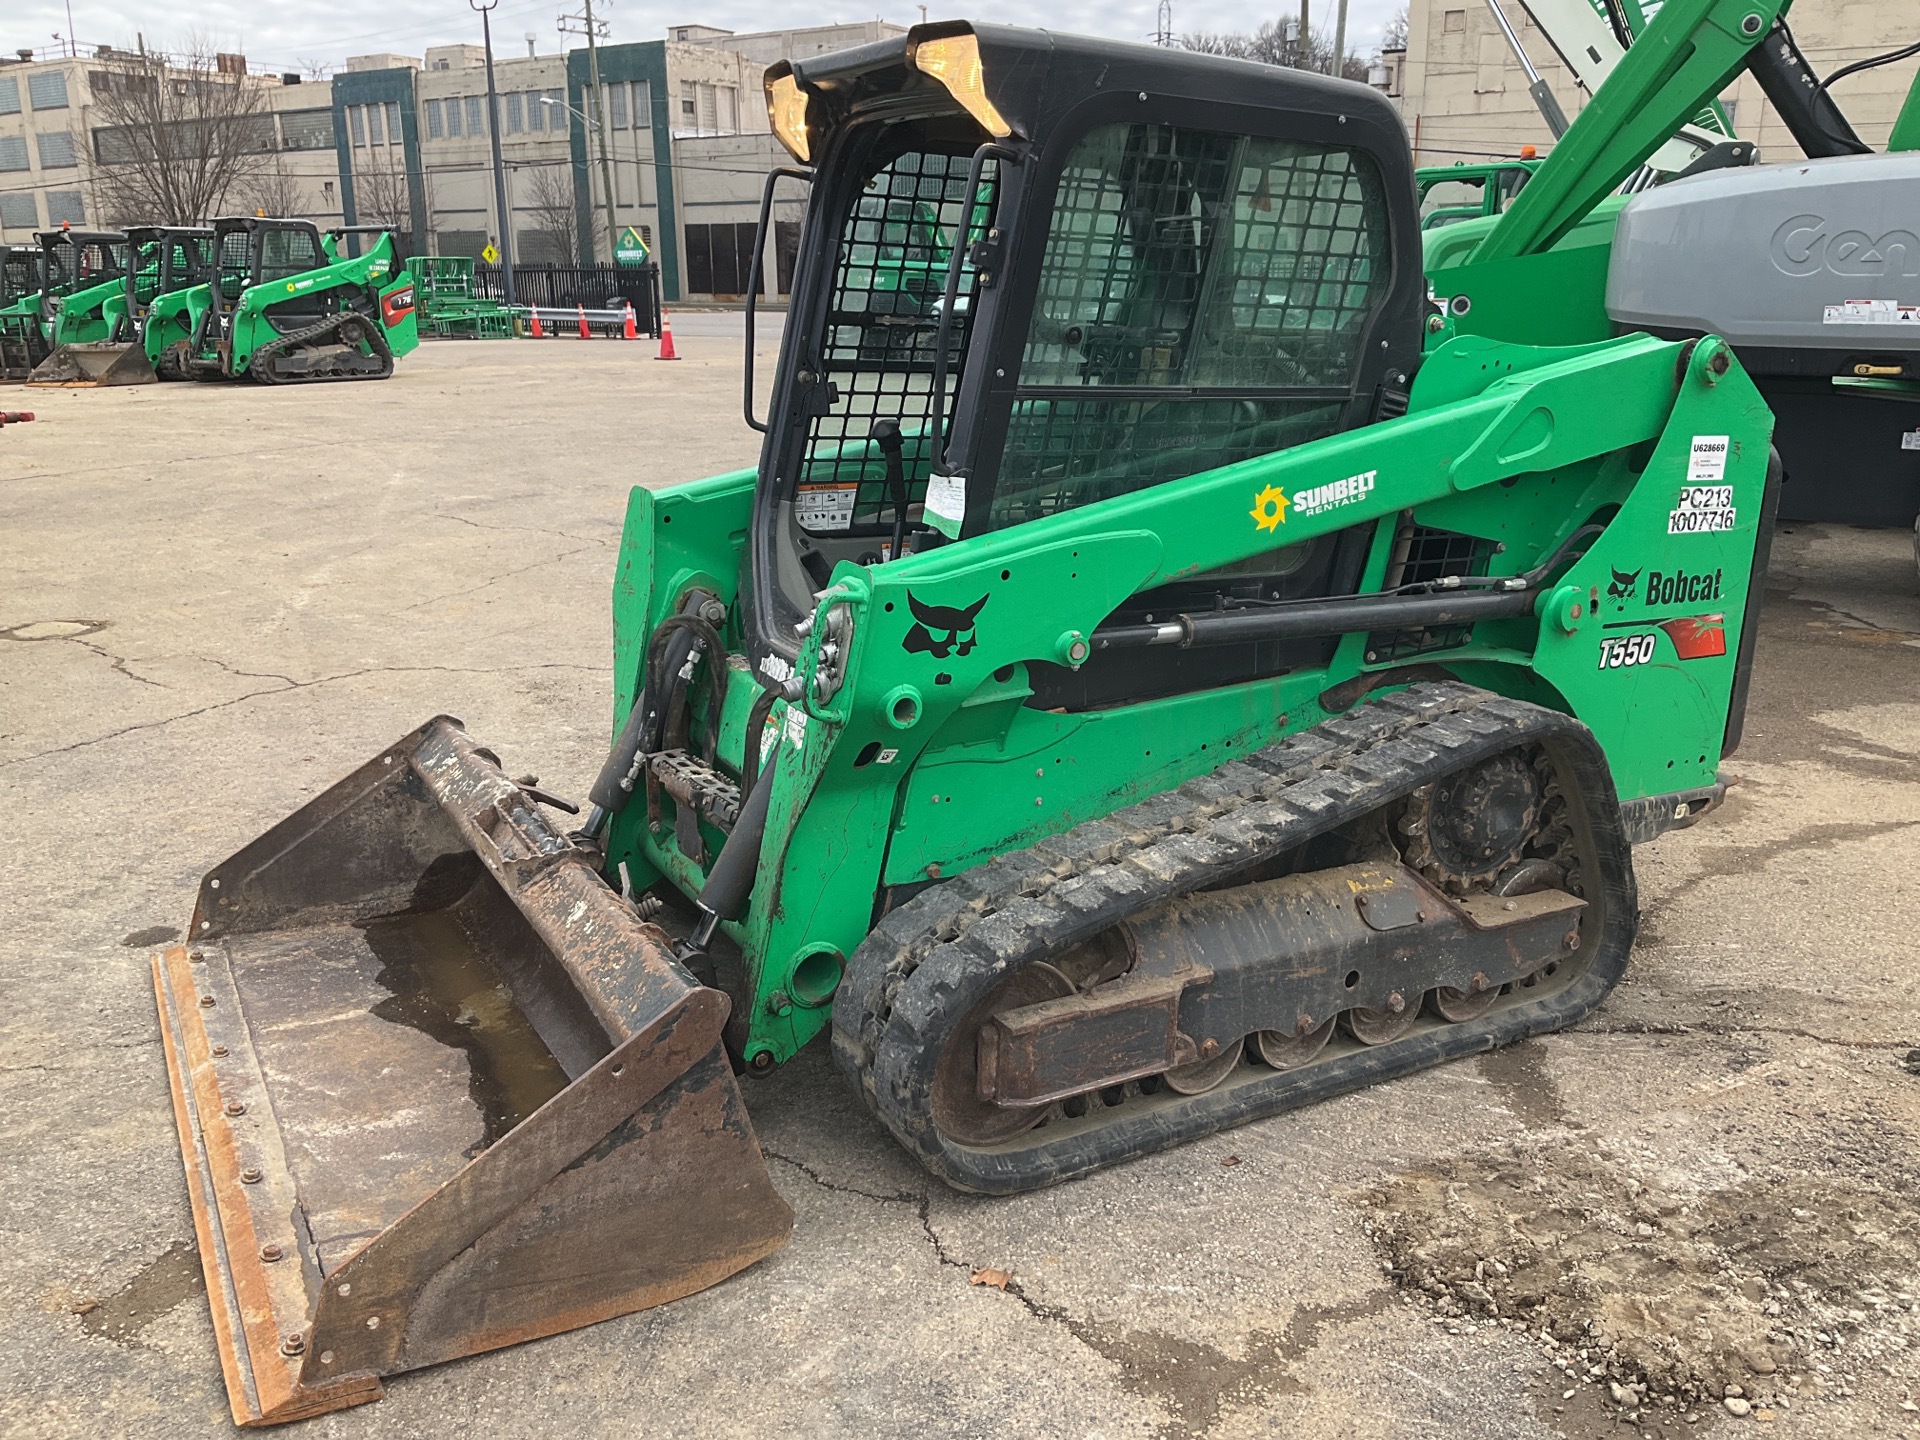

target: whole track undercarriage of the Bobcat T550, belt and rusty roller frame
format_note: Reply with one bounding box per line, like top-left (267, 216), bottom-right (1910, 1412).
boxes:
top-left (833, 684), bottom-right (1634, 1192)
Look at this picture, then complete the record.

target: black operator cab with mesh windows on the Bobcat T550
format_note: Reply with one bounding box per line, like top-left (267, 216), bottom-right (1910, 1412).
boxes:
top-left (749, 23), bottom-right (1425, 707)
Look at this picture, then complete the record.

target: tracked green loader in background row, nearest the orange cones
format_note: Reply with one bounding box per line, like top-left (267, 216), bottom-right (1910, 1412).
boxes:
top-left (164, 215), bottom-right (420, 384)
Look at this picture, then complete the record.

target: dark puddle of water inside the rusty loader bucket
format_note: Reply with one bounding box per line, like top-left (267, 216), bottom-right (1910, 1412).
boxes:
top-left (365, 910), bottom-right (566, 1148)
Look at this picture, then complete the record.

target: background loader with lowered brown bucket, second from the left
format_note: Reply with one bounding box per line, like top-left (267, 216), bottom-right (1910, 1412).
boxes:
top-left (27, 227), bottom-right (154, 390)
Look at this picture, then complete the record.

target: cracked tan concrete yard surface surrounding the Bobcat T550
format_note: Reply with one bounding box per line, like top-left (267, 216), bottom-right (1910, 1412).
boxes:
top-left (0, 341), bottom-right (1920, 1440)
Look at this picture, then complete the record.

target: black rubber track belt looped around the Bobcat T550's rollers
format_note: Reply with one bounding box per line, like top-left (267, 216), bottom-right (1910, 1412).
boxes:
top-left (833, 682), bottom-right (1638, 1194)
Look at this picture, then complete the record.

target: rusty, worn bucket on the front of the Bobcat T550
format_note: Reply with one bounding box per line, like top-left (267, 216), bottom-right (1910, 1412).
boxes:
top-left (154, 716), bottom-right (793, 1425)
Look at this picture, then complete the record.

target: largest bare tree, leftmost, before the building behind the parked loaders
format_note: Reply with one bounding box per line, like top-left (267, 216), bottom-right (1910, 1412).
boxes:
top-left (88, 40), bottom-right (278, 225)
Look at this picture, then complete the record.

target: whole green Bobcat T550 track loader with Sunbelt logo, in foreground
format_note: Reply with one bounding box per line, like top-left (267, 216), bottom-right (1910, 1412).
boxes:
top-left (154, 0), bottom-right (1778, 1425)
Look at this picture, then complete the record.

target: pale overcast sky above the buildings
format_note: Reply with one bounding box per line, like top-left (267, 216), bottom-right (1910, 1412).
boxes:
top-left (11, 0), bottom-right (1400, 71)
